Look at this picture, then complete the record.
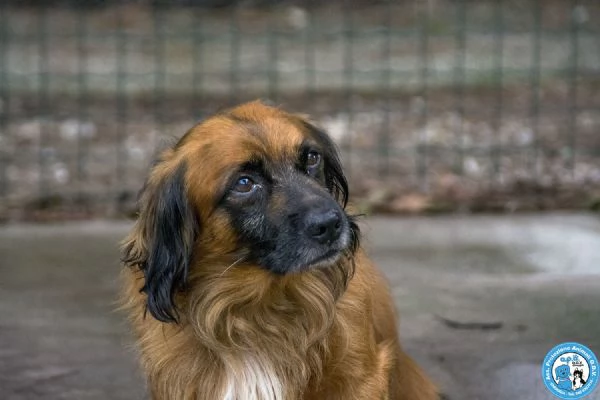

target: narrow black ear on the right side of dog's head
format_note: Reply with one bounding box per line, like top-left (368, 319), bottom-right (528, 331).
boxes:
top-left (300, 116), bottom-right (349, 207)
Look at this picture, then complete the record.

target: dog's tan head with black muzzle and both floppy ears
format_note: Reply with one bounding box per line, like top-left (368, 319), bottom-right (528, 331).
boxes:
top-left (123, 102), bottom-right (358, 322)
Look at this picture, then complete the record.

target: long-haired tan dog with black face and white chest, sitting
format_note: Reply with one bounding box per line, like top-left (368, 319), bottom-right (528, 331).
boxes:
top-left (122, 101), bottom-right (438, 400)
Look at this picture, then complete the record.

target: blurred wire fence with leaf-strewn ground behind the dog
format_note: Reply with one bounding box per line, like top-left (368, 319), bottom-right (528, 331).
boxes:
top-left (0, 0), bottom-right (600, 220)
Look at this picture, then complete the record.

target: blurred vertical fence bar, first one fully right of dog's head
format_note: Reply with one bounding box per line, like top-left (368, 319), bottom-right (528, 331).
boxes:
top-left (378, 1), bottom-right (394, 177)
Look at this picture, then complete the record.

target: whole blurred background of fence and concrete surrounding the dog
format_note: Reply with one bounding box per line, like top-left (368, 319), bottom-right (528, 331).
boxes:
top-left (0, 0), bottom-right (600, 400)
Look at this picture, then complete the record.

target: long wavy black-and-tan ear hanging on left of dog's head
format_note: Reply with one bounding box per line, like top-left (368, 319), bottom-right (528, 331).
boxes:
top-left (122, 158), bottom-right (198, 322)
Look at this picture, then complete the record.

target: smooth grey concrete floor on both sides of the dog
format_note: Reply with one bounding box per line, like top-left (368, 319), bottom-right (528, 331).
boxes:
top-left (0, 214), bottom-right (600, 400)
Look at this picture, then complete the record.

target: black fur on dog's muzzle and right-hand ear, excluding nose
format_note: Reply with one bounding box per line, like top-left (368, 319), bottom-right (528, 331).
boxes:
top-left (222, 124), bottom-right (359, 274)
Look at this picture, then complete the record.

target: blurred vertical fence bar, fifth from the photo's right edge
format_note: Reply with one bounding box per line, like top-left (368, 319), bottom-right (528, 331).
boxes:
top-left (416, 1), bottom-right (429, 191)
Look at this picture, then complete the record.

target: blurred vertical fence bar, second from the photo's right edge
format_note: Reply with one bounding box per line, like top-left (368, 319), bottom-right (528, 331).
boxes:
top-left (529, 0), bottom-right (542, 181)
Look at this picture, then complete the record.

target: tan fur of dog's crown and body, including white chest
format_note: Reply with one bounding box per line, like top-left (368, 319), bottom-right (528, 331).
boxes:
top-left (123, 102), bottom-right (438, 400)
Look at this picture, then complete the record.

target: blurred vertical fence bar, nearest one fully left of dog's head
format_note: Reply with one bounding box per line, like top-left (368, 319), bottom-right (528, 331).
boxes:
top-left (114, 7), bottom-right (128, 212)
